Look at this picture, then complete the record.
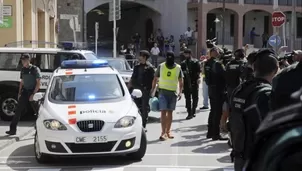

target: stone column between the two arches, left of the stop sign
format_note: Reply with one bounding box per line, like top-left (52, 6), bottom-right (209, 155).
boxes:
top-left (233, 13), bottom-right (244, 50)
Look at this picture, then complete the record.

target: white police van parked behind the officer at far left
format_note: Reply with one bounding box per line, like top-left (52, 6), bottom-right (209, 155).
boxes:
top-left (0, 47), bottom-right (97, 121)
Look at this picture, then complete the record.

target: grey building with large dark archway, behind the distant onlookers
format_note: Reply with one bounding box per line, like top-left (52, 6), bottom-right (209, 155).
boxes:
top-left (84, 0), bottom-right (188, 52)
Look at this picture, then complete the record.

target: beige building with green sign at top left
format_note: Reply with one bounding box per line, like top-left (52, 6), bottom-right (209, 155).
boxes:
top-left (0, 0), bottom-right (57, 47)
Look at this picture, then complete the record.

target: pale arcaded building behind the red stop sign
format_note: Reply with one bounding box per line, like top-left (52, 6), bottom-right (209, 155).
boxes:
top-left (188, 0), bottom-right (302, 52)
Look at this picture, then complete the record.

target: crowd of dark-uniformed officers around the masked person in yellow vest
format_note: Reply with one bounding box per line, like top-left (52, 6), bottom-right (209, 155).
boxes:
top-left (125, 42), bottom-right (302, 171)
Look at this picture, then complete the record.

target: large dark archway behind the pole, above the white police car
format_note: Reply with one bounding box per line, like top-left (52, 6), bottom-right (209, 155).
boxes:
top-left (86, 1), bottom-right (160, 56)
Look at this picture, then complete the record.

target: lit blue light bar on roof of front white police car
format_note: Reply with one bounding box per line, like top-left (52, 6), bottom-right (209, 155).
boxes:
top-left (61, 59), bottom-right (109, 69)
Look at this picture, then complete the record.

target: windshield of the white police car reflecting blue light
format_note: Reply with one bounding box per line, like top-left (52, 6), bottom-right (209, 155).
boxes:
top-left (49, 74), bottom-right (124, 102)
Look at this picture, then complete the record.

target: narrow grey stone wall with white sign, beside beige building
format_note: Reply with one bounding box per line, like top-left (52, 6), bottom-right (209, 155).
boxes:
top-left (57, 0), bottom-right (85, 42)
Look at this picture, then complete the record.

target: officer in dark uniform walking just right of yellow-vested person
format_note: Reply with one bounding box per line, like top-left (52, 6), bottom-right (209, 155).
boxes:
top-left (181, 49), bottom-right (201, 120)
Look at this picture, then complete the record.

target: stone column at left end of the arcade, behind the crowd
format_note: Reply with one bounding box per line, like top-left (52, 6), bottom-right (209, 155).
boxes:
top-left (197, 3), bottom-right (207, 55)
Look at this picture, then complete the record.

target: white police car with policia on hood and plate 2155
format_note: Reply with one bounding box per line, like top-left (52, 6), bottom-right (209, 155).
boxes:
top-left (34, 60), bottom-right (147, 163)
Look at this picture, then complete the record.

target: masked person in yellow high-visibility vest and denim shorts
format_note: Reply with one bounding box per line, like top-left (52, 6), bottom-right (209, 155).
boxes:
top-left (151, 52), bottom-right (184, 141)
